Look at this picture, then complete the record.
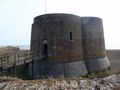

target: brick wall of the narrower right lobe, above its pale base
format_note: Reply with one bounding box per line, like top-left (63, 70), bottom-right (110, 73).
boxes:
top-left (81, 17), bottom-right (106, 59)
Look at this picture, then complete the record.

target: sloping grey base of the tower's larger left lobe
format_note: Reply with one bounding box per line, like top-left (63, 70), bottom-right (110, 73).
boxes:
top-left (29, 60), bottom-right (88, 79)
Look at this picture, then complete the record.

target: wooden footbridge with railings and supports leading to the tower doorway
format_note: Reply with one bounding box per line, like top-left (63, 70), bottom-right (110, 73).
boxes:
top-left (0, 51), bottom-right (47, 79)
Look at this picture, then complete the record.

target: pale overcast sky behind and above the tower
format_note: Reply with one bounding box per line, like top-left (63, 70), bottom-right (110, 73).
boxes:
top-left (0, 0), bottom-right (120, 49)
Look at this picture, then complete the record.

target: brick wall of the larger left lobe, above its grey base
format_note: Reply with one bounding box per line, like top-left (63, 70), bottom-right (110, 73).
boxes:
top-left (31, 14), bottom-right (83, 62)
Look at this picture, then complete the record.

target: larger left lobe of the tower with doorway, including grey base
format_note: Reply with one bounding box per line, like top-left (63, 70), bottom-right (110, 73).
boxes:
top-left (31, 14), bottom-right (87, 77)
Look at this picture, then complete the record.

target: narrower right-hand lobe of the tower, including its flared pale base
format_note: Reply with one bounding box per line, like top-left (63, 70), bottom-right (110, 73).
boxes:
top-left (81, 17), bottom-right (110, 72)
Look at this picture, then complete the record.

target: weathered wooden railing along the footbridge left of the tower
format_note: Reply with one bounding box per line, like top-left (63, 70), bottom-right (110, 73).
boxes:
top-left (0, 51), bottom-right (33, 69)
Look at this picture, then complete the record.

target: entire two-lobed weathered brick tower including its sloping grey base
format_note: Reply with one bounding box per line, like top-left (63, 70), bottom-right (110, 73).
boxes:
top-left (31, 14), bottom-right (110, 77)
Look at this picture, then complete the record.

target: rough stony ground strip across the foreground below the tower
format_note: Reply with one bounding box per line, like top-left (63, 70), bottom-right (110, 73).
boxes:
top-left (0, 74), bottom-right (120, 90)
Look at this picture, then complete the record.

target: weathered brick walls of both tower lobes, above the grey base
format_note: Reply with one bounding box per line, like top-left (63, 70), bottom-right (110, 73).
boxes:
top-left (31, 14), bottom-right (106, 62)
